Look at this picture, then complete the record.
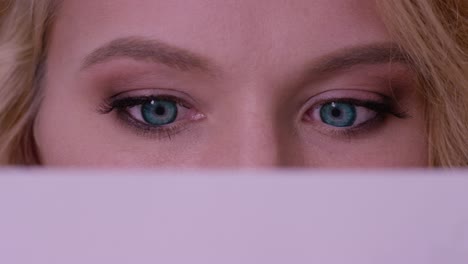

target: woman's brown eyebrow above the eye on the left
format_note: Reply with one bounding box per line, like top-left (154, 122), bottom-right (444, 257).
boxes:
top-left (81, 37), bottom-right (214, 72)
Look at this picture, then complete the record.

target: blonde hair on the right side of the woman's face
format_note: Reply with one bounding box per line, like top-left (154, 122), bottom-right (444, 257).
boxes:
top-left (378, 0), bottom-right (468, 167)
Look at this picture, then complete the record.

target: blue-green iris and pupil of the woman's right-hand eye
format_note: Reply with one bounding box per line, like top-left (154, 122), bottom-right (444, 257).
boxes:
top-left (320, 102), bottom-right (357, 127)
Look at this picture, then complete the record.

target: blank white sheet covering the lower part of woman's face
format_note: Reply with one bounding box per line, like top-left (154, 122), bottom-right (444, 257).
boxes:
top-left (0, 169), bottom-right (468, 264)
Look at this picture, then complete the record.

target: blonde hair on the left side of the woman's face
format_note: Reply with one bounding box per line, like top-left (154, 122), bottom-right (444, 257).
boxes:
top-left (0, 0), bottom-right (56, 165)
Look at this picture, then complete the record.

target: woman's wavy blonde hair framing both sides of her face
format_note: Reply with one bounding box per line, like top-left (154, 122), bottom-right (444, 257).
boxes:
top-left (0, 0), bottom-right (468, 167)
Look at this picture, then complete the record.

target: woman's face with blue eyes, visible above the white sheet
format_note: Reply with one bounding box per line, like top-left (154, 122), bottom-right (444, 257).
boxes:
top-left (35, 0), bottom-right (427, 167)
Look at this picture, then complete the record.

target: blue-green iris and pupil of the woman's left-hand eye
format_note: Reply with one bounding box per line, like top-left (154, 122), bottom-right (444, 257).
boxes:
top-left (141, 100), bottom-right (178, 126)
